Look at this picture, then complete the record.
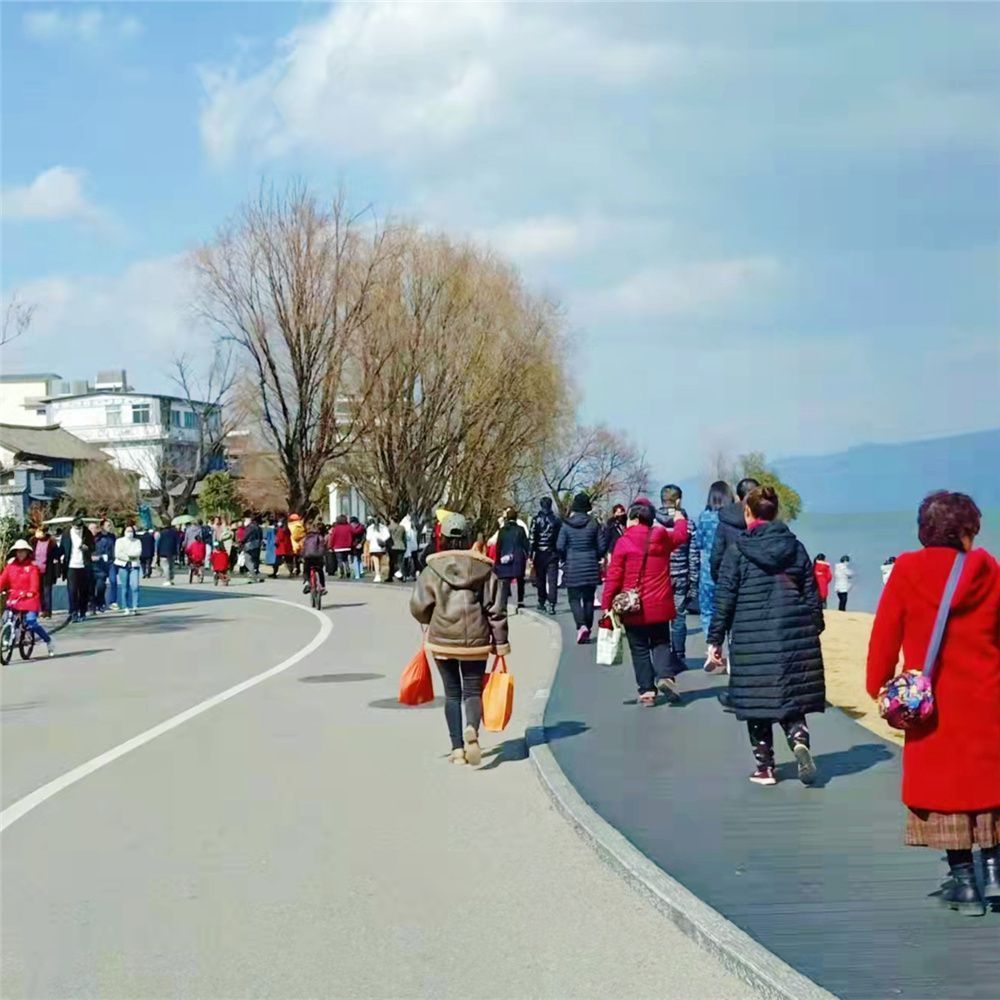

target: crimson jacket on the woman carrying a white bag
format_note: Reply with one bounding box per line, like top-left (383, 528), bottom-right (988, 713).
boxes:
top-left (601, 521), bottom-right (688, 625)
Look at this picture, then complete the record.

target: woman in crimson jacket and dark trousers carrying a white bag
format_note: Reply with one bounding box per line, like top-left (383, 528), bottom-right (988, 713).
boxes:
top-left (601, 497), bottom-right (688, 706)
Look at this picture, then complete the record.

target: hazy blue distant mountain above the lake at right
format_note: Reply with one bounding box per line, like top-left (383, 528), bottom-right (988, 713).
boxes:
top-left (774, 428), bottom-right (1000, 514)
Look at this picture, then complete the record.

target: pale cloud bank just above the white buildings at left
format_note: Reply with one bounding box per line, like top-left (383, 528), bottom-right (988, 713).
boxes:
top-left (4, 255), bottom-right (209, 389)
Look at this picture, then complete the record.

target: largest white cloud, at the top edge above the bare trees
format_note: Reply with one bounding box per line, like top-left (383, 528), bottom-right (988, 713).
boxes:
top-left (201, 2), bottom-right (684, 163)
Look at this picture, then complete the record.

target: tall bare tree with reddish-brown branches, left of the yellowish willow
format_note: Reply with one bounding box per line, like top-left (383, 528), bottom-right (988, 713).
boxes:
top-left (193, 184), bottom-right (390, 510)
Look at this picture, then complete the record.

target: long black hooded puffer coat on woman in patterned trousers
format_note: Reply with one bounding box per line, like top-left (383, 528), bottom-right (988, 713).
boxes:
top-left (708, 521), bottom-right (826, 721)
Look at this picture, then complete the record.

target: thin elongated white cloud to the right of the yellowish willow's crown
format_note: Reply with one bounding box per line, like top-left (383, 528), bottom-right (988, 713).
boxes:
top-left (574, 256), bottom-right (781, 321)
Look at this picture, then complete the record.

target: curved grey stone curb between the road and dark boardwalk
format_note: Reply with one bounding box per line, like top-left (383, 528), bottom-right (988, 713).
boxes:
top-left (525, 611), bottom-right (836, 1000)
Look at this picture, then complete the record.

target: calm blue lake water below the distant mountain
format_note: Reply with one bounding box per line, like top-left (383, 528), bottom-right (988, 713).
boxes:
top-left (791, 510), bottom-right (1000, 611)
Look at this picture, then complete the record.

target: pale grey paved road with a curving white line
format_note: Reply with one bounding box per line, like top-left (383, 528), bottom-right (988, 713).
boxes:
top-left (2, 582), bottom-right (750, 1000)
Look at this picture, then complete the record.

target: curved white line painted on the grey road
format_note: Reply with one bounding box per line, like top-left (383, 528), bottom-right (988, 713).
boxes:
top-left (0, 596), bottom-right (333, 833)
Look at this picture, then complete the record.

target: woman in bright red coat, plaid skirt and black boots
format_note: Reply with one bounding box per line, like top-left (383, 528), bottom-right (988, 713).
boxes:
top-left (867, 491), bottom-right (1000, 915)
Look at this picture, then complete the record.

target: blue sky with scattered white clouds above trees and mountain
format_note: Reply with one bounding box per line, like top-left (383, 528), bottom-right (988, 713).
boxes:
top-left (0, 2), bottom-right (1000, 477)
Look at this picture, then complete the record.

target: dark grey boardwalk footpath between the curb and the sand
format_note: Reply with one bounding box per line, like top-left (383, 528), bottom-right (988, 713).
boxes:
top-left (545, 615), bottom-right (1000, 1000)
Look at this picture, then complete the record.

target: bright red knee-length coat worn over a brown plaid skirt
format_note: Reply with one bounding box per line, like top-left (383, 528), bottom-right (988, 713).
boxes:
top-left (867, 547), bottom-right (1000, 813)
